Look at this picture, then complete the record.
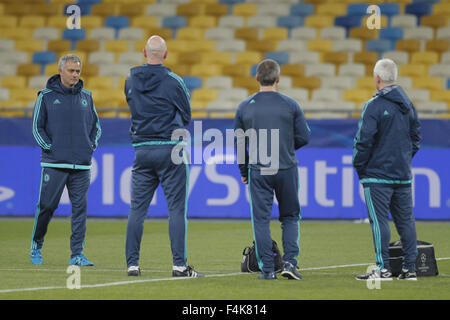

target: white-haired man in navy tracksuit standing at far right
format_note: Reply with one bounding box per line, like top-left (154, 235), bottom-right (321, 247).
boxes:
top-left (353, 59), bottom-right (421, 280)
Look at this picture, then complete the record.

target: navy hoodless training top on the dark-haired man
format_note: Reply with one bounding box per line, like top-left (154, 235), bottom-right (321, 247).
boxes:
top-left (234, 91), bottom-right (311, 177)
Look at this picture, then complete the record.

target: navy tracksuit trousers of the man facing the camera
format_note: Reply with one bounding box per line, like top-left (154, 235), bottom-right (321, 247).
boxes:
top-left (31, 167), bottom-right (91, 258)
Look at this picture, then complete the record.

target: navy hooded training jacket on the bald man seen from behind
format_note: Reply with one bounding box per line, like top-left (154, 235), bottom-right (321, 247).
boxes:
top-left (125, 64), bottom-right (191, 147)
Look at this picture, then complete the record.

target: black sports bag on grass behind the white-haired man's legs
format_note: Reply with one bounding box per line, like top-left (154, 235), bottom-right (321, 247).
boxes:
top-left (389, 240), bottom-right (439, 277)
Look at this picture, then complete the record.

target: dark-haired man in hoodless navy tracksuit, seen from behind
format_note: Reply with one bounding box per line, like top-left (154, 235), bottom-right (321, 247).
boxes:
top-left (234, 59), bottom-right (310, 280)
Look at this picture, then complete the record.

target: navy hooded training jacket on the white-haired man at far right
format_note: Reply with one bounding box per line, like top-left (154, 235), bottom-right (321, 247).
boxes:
top-left (353, 85), bottom-right (421, 185)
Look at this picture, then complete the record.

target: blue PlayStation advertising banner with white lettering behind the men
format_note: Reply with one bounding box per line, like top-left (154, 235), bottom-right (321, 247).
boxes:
top-left (0, 119), bottom-right (450, 220)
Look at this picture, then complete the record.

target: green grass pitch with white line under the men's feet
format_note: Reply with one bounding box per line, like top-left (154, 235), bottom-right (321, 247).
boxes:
top-left (0, 218), bottom-right (450, 300)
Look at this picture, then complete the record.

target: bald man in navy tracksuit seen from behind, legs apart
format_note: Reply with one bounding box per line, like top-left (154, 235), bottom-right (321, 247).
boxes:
top-left (125, 36), bottom-right (203, 277)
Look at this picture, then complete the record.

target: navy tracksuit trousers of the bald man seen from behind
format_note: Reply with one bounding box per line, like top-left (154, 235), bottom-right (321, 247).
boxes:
top-left (125, 145), bottom-right (189, 267)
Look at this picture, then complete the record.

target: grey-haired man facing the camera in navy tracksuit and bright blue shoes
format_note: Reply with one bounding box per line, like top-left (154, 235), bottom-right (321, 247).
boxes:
top-left (30, 55), bottom-right (101, 266)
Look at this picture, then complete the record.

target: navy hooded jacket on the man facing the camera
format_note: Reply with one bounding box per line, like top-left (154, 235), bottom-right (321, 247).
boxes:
top-left (32, 74), bottom-right (101, 170)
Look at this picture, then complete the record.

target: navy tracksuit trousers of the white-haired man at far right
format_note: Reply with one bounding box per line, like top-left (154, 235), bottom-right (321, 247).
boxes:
top-left (364, 183), bottom-right (417, 271)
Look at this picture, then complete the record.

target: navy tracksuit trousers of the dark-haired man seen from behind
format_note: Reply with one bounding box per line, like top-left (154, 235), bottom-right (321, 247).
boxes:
top-left (248, 166), bottom-right (301, 272)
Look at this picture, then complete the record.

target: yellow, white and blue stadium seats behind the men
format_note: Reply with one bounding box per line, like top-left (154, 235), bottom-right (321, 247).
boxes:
top-left (0, 0), bottom-right (450, 118)
